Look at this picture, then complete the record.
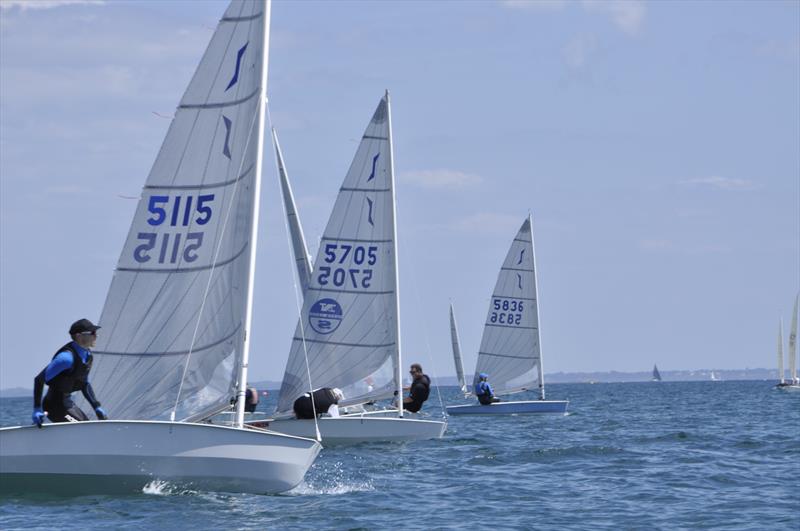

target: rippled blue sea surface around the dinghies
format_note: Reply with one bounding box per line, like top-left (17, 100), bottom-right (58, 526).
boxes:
top-left (0, 382), bottom-right (800, 530)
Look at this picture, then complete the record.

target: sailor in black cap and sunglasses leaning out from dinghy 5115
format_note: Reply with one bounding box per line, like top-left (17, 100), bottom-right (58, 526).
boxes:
top-left (33, 319), bottom-right (108, 428)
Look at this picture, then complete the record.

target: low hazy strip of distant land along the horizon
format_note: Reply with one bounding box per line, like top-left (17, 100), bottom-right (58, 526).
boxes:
top-left (0, 369), bottom-right (777, 398)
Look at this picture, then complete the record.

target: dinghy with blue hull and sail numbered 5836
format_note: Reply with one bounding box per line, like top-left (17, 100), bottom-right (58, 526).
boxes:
top-left (447, 216), bottom-right (569, 415)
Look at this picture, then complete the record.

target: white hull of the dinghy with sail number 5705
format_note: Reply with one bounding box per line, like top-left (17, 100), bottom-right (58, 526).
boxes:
top-left (260, 415), bottom-right (447, 446)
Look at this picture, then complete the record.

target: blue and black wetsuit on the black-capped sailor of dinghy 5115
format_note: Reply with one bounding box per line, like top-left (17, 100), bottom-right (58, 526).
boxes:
top-left (33, 341), bottom-right (100, 422)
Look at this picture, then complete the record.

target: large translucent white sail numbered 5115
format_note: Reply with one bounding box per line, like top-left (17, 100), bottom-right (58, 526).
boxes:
top-left (85, 1), bottom-right (264, 420)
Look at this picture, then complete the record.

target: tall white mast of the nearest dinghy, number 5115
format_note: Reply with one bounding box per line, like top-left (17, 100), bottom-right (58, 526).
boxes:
top-left (236, 0), bottom-right (272, 428)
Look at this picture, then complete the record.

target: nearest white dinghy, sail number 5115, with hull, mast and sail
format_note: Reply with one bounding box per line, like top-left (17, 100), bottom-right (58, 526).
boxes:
top-left (0, 0), bottom-right (321, 493)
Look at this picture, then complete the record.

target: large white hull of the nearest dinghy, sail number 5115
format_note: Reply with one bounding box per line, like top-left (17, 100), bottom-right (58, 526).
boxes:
top-left (0, 420), bottom-right (321, 494)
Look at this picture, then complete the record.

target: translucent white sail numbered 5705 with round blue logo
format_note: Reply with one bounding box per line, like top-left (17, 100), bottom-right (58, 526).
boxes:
top-left (277, 93), bottom-right (400, 415)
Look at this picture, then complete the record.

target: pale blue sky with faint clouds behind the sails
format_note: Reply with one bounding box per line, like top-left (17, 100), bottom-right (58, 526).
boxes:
top-left (0, 0), bottom-right (800, 388)
